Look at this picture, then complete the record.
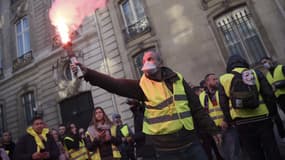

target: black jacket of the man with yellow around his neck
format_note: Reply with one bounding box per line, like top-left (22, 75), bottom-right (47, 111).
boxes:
top-left (14, 134), bottom-right (59, 160)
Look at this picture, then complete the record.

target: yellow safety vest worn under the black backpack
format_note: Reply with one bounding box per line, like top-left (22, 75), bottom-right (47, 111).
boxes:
top-left (220, 68), bottom-right (269, 120)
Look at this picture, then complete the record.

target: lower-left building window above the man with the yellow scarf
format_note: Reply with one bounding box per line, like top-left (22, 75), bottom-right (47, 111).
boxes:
top-left (22, 92), bottom-right (37, 124)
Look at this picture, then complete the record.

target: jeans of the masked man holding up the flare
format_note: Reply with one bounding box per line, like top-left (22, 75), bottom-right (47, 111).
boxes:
top-left (157, 142), bottom-right (208, 160)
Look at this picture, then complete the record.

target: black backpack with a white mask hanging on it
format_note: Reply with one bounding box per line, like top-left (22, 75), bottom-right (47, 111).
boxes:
top-left (230, 70), bottom-right (259, 109)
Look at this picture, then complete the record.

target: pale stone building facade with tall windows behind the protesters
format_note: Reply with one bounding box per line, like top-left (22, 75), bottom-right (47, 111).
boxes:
top-left (0, 0), bottom-right (285, 137)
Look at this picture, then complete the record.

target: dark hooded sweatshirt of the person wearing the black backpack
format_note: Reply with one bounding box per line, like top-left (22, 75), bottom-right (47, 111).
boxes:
top-left (219, 55), bottom-right (277, 122)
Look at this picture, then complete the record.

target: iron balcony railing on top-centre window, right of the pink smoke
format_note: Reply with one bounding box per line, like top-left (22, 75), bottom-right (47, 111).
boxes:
top-left (123, 17), bottom-right (151, 41)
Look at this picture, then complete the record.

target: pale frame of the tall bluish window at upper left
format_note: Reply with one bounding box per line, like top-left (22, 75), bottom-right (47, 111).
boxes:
top-left (15, 15), bottom-right (32, 58)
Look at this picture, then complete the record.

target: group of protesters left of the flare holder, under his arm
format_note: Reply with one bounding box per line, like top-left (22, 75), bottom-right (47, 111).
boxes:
top-left (0, 99), bottom-right (155, 160)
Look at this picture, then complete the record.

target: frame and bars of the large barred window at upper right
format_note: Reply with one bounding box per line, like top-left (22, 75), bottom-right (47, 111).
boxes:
top-left (214, 6), bottom-right (268, 64)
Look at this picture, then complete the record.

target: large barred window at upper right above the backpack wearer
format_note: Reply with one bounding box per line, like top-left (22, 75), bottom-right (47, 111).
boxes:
top-left (215, 7), bottom-right (266, 64)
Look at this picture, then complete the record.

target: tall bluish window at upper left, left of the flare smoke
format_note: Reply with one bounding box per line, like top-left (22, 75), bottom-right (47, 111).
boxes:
top-left (16, 16), bottom-right (31, 57)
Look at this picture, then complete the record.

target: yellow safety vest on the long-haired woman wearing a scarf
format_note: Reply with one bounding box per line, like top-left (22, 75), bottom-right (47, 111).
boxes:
top-left (86, 125), bottom-right (122, 160)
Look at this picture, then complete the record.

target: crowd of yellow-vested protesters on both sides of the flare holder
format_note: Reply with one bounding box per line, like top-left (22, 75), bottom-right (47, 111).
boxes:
top-left (0, 53), bottom-right (285, 160)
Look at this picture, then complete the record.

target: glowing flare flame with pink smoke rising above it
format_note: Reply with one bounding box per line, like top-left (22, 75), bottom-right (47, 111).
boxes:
top-left (49, 0), bottom-right (107, 44)
